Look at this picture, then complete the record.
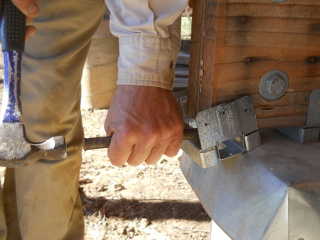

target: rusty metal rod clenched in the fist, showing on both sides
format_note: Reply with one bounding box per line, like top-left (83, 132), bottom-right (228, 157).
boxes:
top-left (83, 129), bottom-right (199, 150)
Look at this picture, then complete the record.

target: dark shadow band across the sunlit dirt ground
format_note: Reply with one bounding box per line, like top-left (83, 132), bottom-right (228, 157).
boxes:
top-left (79, 188), bottom-right (210, 222)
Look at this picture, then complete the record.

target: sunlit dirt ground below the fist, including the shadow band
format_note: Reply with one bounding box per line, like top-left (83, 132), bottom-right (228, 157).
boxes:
top-left (79, 110), bottom-right (210, 240)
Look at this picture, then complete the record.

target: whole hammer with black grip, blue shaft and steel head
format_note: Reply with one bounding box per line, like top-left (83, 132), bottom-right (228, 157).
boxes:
top-left (0, 0), bottom-right (67, 167)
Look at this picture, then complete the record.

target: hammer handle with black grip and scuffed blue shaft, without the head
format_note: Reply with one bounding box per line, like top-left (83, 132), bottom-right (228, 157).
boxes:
top-left (0, 0), bottom-right (26, 123)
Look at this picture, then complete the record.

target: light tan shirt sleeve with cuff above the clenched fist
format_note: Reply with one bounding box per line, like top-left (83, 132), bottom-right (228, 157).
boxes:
top-left (106, 0), bottom-right (187, 89)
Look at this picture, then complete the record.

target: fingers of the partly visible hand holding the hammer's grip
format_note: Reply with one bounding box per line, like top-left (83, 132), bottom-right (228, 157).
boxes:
top-left (11, 0), bottom-right (40, 41)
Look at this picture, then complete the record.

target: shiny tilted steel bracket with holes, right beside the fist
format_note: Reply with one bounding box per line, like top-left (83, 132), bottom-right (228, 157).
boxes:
top-left (182, 96), bottom-right (261, 168)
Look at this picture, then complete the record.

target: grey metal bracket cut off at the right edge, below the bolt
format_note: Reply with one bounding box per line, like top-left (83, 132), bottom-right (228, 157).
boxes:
top-left (277, 89), bottom-right (320, 143)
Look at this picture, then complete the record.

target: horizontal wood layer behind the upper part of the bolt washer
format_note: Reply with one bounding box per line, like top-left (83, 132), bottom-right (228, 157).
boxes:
top-left (213, 61), bottom-right (320, 97)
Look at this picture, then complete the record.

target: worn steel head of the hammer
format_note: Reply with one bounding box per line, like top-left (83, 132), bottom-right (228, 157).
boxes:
top-left (0, 123), bottom-right (67, 168)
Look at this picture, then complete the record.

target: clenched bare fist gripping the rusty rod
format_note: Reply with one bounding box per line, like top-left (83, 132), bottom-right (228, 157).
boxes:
top-left (105, 85), bottom-right (183, 167)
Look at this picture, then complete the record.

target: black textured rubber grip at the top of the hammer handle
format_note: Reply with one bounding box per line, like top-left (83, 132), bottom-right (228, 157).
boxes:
top-left (1, 0), bottom-right (26, 52)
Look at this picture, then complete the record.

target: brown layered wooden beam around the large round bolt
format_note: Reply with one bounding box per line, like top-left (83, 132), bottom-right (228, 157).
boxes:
top-left (188, 0), bottom-right (320, 128)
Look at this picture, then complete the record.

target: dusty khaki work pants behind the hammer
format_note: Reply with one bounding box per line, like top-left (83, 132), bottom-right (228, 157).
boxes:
top-left (0, 0), bottom-right (117, 240)
